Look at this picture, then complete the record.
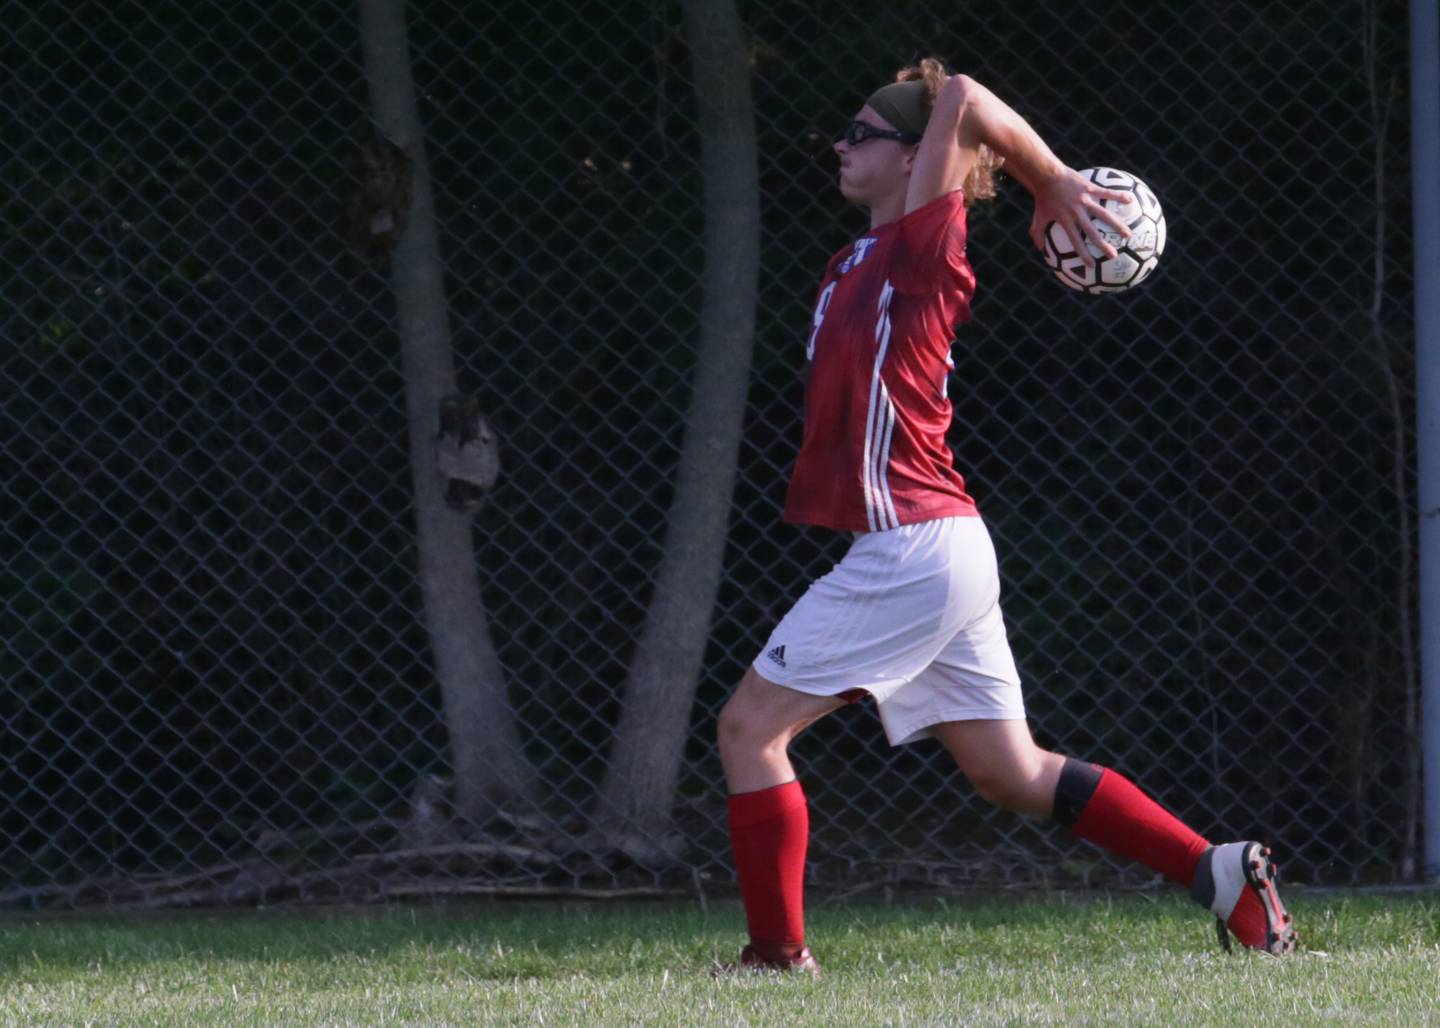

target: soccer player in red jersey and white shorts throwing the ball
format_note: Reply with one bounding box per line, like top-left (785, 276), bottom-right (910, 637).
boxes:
top-left (717, 59), bottom-right (1296, 973)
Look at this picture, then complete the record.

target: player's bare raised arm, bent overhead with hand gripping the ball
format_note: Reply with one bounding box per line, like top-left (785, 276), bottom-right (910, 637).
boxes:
top-left (906, 75), bottom-right (1130, 262)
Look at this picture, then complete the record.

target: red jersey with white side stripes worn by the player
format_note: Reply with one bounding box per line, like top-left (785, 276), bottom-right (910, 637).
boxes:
top-left (785, 190), bottom-right (976, 531)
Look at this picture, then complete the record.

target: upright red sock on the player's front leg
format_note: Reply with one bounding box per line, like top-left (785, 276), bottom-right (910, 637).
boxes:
top-left (730, 782), bottom-right (809, 959)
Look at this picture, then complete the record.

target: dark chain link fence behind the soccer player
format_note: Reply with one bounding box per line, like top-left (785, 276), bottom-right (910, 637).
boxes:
top-left (0, 0), bottom-right (1420, 906)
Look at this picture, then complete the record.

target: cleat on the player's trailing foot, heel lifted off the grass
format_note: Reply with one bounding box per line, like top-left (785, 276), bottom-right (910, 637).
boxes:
top-left (1189, 842), bottom-right (1299, 956)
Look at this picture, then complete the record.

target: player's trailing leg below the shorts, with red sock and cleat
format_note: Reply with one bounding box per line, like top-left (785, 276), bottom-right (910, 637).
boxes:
top-left (935, 720), bottom-right (1296, 956)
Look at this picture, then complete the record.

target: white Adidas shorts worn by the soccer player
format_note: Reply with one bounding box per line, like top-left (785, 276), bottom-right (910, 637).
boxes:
top-left (755, 517), bottom-right (1025, 746)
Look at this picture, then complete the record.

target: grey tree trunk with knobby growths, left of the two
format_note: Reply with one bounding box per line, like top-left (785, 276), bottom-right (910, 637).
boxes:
top-left (360, 0), bottom-right (536, 822)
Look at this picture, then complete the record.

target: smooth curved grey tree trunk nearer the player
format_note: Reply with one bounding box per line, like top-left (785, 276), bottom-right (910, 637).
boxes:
top-left (595, 0), bottom-right (760, 858)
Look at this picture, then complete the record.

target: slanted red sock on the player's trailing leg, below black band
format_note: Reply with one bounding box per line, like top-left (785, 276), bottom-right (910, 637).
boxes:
top-left (1070, 767), bottom-right (1210, 888)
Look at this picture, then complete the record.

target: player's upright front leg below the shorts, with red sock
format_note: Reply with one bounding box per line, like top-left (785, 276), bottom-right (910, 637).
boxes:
top-left (717, 668), bottom-right (845, 975)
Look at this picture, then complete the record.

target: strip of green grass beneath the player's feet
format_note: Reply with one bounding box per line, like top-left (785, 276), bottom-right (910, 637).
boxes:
top-left (0, 890), bottom-right (1440, 1025)
